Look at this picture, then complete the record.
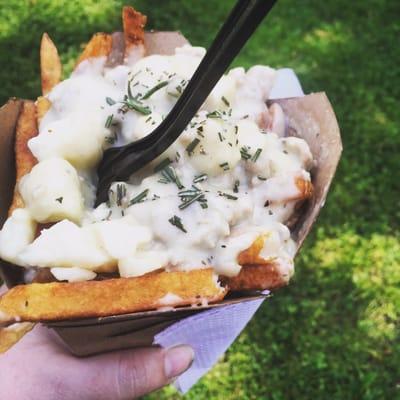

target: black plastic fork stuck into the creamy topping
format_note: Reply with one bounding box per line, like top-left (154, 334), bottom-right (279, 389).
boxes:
top-left (96, 0), bottom-right (277, 205)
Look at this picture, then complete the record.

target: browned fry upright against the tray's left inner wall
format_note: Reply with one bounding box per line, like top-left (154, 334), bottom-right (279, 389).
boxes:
top-left (8, 100), bottom-right (38, 215)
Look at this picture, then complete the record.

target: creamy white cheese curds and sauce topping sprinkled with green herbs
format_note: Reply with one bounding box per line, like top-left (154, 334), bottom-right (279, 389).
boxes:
top-left (0, 45), bottom-right (312, 282)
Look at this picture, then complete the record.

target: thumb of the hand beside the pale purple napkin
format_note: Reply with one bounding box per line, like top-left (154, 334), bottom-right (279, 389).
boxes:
top-left (65, 345), bottom-right (194, 400)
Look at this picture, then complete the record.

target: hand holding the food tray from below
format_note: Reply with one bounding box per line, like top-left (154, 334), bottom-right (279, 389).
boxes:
top-left (0, 286), bottom-right (193, 400)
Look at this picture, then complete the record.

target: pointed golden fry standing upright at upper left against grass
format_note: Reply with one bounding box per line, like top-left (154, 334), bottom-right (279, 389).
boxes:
top-left (40, 33), bottom-right (62, 96)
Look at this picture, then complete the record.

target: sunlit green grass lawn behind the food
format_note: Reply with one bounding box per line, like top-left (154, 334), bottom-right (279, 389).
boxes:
top-left (0, 0), bottom-right (400, 400)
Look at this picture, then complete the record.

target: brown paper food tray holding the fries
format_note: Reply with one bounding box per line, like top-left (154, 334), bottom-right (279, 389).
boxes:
top-left (0, 32), bottom-right (342, 356)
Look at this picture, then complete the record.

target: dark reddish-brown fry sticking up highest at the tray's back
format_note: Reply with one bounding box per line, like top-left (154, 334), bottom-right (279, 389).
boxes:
top-left (122, 6), bottom-right (147, 64)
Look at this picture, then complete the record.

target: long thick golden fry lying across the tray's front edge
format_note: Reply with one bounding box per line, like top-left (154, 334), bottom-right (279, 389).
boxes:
top-left (0, 268), bottom-right (226, 323)
